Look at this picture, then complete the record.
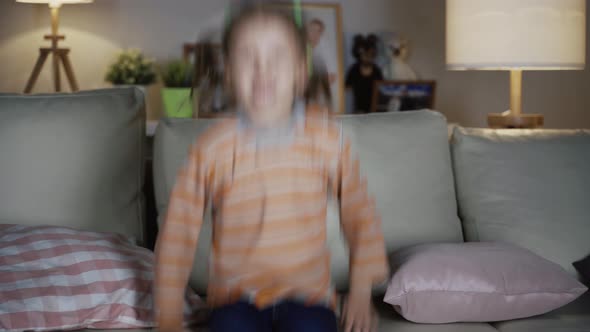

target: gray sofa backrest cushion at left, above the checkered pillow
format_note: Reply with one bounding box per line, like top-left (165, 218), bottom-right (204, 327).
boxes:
top-left (0, 88), bottom-right (145, 243)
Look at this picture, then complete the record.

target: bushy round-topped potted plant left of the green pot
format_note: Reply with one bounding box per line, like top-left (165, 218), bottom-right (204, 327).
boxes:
top-left (105, 48), bottom-right (158, 120)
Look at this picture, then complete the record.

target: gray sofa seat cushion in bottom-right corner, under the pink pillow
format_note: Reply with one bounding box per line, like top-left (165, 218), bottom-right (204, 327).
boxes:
top-left (493, 292), bottom-right (590, 332)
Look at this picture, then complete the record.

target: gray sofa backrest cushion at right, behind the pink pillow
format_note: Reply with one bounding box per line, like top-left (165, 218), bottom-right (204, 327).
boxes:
top-left (452, 128), bottom-right (590, 273)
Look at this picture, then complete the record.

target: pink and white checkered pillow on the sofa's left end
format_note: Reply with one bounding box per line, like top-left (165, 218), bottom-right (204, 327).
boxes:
top-left (0, 225), bottom-right (204, 331)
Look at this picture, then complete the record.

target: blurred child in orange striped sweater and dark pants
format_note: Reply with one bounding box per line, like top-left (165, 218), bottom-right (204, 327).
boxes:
top-left (155, 6), bottom-right (387, 332)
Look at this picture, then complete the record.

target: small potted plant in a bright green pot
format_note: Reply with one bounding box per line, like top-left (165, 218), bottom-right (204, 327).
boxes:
top-left (162, 60), bottom-right (194, 118)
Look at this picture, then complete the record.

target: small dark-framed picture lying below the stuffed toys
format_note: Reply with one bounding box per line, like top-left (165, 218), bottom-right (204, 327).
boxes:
top-left (371, 81), bottom-right (436, 112)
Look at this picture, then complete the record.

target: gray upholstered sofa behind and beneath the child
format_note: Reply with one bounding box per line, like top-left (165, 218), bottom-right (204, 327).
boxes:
top-left (0, 89), bottom-right (590, 332)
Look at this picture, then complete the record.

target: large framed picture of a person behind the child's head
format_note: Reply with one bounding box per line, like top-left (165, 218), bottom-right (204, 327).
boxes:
top-left (277, 3), bottom-right (345, 113)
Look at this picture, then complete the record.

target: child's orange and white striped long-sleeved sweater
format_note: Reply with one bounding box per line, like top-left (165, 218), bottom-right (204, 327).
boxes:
top-left (155, 110), bottom-right (388, 330)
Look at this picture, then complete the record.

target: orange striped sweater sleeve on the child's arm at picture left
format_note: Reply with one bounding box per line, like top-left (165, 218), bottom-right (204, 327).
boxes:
top-left (154, 145), bottom-right (210, 331)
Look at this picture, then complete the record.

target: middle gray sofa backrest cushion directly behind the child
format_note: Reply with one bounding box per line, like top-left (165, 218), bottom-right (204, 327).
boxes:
top-left (154, 111), bottom-right (463, 292)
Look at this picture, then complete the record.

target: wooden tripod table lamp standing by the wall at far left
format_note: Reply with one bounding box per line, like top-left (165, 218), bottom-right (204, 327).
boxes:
top-left (16, 0), bottom-right (93, 93)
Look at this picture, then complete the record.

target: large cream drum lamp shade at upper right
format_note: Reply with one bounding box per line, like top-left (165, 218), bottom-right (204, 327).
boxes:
top-left (446, 0), bottom-right (586, 70)
